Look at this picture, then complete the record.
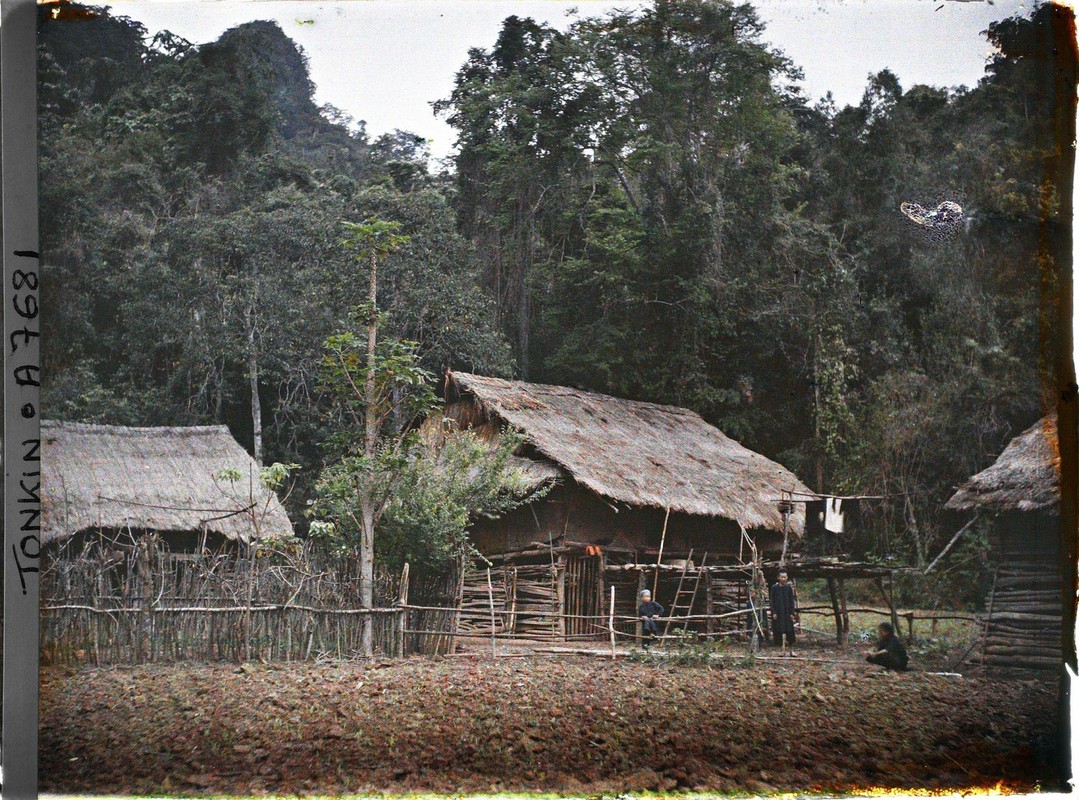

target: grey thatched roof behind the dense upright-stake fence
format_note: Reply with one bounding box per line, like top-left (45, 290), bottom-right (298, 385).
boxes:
top-left (41, 420), bottom-right (292, 542)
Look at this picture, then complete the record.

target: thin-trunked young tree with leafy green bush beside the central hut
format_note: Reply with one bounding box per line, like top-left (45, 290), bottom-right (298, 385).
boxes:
top-left (310, 226), bottom-right (547, 655)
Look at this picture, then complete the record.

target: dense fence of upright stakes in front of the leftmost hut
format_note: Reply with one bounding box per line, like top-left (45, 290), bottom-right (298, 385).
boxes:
top-left (41, 535), bottom-right (453, 665)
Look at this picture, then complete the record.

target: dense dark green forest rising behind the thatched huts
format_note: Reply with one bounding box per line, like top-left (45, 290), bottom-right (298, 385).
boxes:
top-left (39, 0), bottom-right (1069, 600)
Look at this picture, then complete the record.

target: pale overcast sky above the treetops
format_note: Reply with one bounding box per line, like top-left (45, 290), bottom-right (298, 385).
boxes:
top-left (103, 0), bottom-right (1030, 158)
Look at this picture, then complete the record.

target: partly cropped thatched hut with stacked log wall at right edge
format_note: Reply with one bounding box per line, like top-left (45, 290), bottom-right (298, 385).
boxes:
top-left (945, 415), bottom-right (1063, 668)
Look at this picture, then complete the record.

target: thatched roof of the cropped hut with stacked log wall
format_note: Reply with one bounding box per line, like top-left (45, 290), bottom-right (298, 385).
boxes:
top-left (944, 415), bottom-right (1061, 512)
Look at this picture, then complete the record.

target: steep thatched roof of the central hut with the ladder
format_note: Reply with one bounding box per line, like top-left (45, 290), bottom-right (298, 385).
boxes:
top-left (447, 372), bottom-right (809, 534)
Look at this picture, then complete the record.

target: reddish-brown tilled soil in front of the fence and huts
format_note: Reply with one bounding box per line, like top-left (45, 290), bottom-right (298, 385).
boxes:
top-left (41, 654), bottom-right (1056, 795)
